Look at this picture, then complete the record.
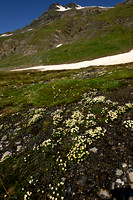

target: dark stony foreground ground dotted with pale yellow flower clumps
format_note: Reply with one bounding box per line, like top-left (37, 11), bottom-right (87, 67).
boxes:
top-left (0, 65), bottom-right (133, 200)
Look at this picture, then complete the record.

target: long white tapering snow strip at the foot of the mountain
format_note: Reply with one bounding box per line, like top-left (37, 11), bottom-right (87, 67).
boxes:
top-left (11, 50), bottom-right (133, 71)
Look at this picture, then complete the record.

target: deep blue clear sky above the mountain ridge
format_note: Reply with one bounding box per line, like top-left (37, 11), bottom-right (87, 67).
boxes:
top-left (0, 0), bottom-right (123, 33)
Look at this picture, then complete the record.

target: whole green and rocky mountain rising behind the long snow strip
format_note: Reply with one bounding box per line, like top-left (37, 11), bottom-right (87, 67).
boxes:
top-left (0, 0), bottom-right (133, 67)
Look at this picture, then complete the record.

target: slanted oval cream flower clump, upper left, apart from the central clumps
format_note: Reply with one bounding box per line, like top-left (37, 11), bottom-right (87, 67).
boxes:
top-left (28, 108), bottom-right (45, 126)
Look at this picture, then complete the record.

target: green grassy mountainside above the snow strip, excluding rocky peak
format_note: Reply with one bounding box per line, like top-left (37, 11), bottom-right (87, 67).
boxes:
top-left (0, 3), bottom-right (133, 68)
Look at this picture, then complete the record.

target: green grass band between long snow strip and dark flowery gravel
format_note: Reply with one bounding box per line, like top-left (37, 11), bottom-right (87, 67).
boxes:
top-left (0, 65), bottom-right (133, 113)
